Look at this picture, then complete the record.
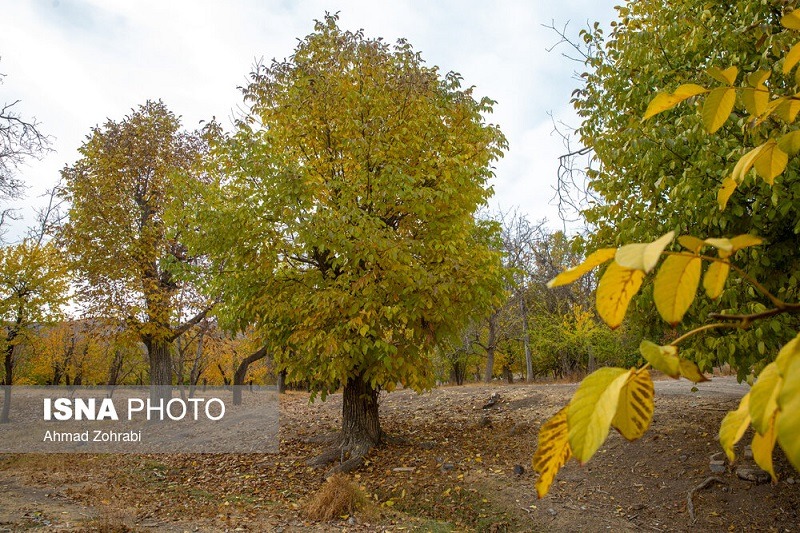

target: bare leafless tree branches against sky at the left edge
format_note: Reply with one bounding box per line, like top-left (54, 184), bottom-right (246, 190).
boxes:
top-left (0, 60), bottom-right (50, 232)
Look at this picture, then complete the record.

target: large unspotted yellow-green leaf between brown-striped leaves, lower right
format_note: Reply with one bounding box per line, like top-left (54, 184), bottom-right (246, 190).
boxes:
top-left (567, 367), bottom-right (633, 464)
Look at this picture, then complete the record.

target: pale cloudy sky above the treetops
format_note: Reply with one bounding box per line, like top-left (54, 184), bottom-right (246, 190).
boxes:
top-left (0, 0), bottom-right (619, 240)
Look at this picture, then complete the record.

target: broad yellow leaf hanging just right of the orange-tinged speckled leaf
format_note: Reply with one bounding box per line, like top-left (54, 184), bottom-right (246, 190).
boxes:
top-left (653, 255), bottom-right (703, 326)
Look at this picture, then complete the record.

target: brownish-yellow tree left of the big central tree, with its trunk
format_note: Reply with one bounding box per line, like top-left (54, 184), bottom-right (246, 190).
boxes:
top-left (61, 101), bottom-right (207, 385)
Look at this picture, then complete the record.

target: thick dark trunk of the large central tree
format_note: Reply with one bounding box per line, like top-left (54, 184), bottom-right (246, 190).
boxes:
top-left (342, 375), bottom-right (381, 449)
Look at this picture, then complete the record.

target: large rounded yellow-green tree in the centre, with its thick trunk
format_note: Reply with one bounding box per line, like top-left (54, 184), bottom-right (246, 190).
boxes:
top-left (190, 16), bottom-right (505, 469)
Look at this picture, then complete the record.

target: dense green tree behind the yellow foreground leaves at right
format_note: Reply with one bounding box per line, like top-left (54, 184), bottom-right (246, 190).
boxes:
top-left (574, 0), bottom-right (800, 377)
